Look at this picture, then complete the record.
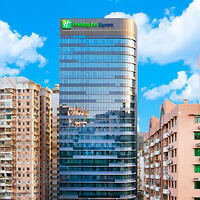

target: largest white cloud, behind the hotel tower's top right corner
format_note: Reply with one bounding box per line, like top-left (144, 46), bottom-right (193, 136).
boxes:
top-left (105, 0), bottom-right (200, 69)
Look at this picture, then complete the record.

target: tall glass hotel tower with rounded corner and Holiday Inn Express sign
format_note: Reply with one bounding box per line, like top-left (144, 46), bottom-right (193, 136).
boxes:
top-left (59, 19), bottom-right (137, 200)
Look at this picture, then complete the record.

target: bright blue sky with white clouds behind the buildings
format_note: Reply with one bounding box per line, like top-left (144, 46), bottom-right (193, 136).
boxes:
top-left (0, 0), bottom-right (200, 132)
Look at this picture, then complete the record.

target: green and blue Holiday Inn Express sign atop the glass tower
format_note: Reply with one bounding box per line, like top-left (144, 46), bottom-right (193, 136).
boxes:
top-left (62, 19), bottom-right (114, 29)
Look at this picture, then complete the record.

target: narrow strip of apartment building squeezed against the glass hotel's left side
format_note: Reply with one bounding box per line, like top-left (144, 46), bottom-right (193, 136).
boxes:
top-left (50, 85), bottom-right (59, 200)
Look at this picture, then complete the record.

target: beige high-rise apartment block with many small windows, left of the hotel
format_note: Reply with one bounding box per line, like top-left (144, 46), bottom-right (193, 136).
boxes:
top-left (0, 77), bottom-right (51, 200)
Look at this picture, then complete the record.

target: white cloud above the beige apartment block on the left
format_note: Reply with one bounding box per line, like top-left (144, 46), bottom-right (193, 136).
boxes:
top-left (0, 20), bottom-right (46, 76)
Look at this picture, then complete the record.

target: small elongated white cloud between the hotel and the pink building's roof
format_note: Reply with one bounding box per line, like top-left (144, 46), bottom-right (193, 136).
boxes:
top-left (143, 71), bottom-right (189, 100)
